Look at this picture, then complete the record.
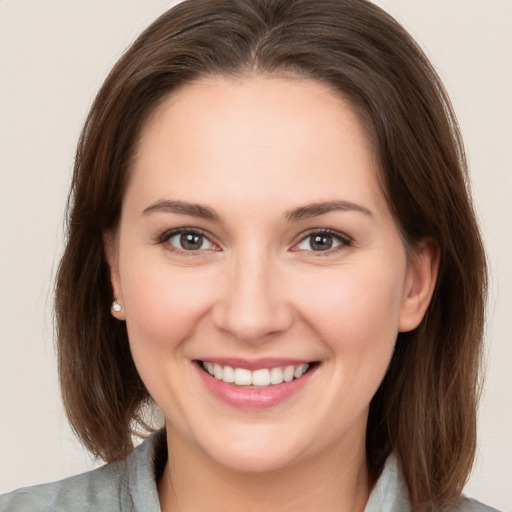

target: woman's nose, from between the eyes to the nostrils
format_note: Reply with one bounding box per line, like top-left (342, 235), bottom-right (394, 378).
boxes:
top-left (212, 251), bottom-right (293, 343)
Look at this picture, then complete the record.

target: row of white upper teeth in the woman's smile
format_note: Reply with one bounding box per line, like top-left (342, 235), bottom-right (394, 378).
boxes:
top-left (203, 362), bottom-right (309, 387)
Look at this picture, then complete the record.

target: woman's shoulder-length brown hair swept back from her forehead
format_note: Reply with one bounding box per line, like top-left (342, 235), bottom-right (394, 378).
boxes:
top-left (56, 0), bottom-right (486, 510)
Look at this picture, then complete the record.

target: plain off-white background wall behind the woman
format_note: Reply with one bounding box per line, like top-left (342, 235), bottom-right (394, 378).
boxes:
top-left (0, 0), bottom-right (512, 511)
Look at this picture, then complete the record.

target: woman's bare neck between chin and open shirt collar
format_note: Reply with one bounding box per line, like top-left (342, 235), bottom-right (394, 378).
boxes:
top-left (158, 428), bottom-right (370, 512)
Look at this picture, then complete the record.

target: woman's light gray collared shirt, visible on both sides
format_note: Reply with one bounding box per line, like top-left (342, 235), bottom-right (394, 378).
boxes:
top-left (0, 431), bottom-right (497, 512)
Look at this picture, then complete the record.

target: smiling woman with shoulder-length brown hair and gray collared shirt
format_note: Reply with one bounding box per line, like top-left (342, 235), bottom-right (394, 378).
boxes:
top-left (0, 0), bottom-right (498, 511)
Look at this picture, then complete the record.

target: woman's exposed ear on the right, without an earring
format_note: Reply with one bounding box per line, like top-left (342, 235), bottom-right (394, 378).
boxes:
top-left (398, 238), bottom-right (440, 332)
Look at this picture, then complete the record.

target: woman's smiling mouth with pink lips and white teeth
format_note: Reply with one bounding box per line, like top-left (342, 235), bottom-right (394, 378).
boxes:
top-left (194, 360), bottom-right (320, 409)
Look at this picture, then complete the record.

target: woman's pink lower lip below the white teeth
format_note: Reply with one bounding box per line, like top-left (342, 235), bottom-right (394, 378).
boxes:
top-left (195, 364), bottom-right (316, 409)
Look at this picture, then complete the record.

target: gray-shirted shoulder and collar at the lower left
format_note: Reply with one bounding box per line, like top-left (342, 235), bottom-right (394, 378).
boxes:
top-left (0, 433), bottom-right (162, 512)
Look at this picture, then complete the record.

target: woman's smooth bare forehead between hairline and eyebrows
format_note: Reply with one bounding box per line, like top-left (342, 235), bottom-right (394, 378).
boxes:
top-left (128, 76), bottom-right (382, 218)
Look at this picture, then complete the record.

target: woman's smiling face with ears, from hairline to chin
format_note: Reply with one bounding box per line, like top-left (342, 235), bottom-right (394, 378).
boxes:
top-left (107, 76), bottom-right (435, 471)
